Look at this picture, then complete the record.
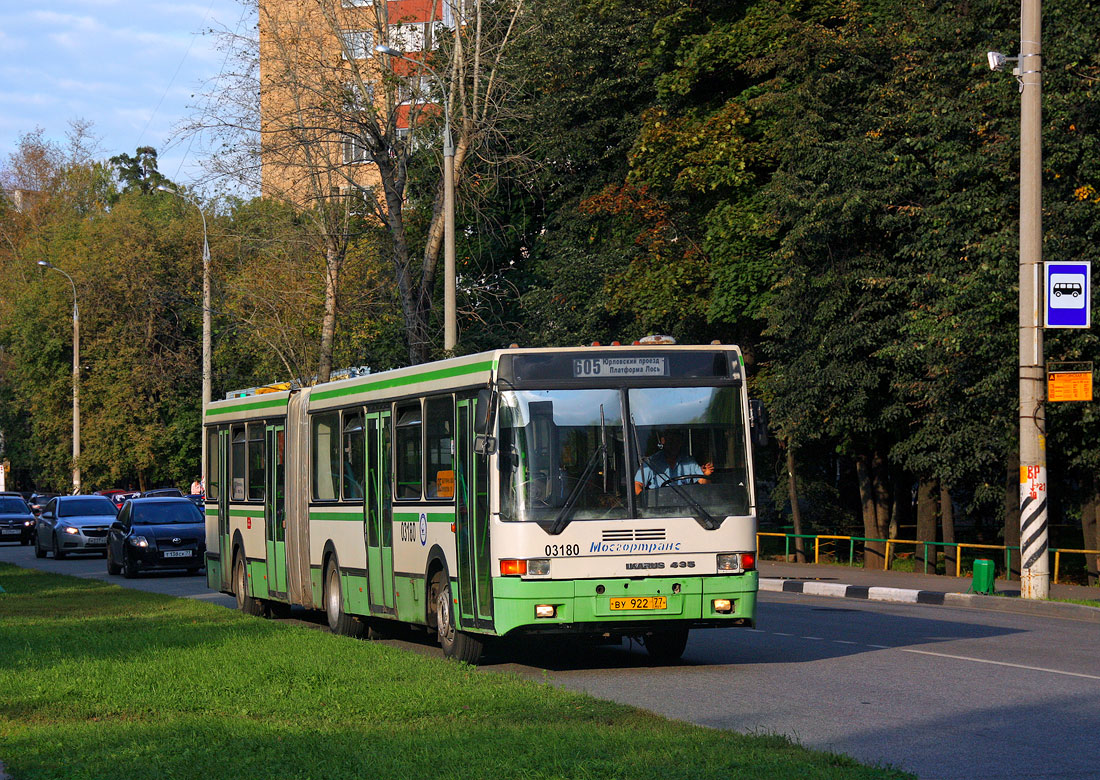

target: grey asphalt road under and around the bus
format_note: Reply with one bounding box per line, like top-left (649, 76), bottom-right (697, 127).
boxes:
top-left (0, 546), bottom-right (1100, 780)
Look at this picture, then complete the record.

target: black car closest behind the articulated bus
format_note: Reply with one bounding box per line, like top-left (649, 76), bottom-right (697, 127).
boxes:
top-left (107, 497), bottom-right (206, 578)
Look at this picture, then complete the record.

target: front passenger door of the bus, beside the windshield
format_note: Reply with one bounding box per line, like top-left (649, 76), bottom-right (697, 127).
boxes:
top-left (455, 400), bottom-right (493, 628)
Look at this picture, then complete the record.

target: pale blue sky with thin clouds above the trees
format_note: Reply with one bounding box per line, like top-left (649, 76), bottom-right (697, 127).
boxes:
top-left (0, 0), bottom-right (245, 190)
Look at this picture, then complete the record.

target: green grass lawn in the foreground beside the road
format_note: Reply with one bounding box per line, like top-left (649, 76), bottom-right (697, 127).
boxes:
top-left (0, 564), bottom-right (910, 780)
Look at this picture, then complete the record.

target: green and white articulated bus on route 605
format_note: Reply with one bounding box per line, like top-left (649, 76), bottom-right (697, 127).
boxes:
top-left (205, 344), bottom-right (762, 662)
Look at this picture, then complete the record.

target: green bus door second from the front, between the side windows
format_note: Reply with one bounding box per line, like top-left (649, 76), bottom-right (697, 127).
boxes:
top-left (363, 411), bottom-right (395, 614)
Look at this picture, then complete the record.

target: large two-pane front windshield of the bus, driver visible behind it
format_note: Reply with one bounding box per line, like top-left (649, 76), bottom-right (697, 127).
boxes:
top-left (499, 386), bottom-right (749, 523)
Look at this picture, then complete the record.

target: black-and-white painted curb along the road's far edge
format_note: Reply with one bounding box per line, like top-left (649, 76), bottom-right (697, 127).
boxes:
top-left (760, 578), bottom-right (1100, 623)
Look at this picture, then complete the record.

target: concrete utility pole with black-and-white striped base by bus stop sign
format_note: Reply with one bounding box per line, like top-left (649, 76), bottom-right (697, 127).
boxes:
top-left (1018, 0), bottom-right (1051, 598)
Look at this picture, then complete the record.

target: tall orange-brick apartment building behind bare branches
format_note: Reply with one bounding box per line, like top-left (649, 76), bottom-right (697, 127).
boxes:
top-left (259, 0), bottom-right (446, 206)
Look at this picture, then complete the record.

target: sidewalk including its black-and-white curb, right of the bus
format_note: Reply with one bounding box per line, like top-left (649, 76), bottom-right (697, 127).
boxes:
top-left (757, 561), bottom-right (1100, 624)
